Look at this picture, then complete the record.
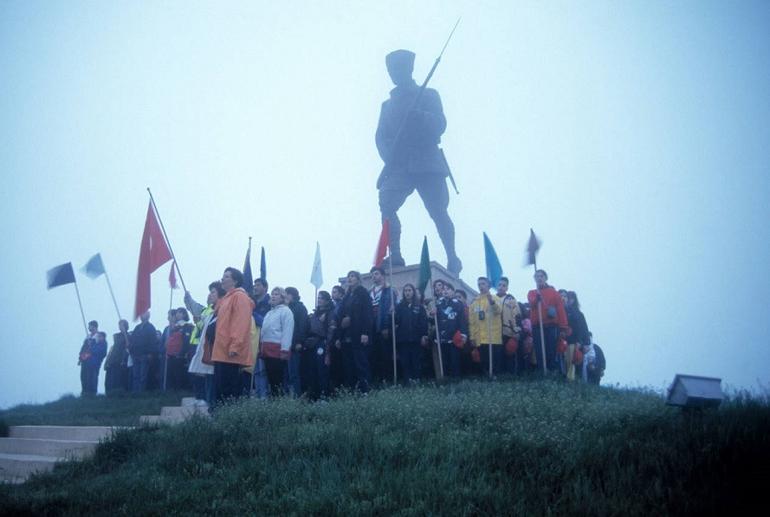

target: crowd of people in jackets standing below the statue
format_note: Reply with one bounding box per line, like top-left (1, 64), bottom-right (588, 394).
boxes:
top-left (79, 267), bottom-right (606, 407)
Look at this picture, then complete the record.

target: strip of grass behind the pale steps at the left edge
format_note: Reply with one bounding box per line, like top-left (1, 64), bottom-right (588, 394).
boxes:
top-left (0, 391), bottom-right (189, 427)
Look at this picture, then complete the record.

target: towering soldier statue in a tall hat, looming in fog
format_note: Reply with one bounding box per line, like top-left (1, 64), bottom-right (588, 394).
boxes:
top-left (376, 50), bottom-right (462, 274)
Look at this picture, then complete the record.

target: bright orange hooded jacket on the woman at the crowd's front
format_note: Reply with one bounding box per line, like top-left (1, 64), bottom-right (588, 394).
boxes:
top-left (211, 287), bottom-right (254, 366)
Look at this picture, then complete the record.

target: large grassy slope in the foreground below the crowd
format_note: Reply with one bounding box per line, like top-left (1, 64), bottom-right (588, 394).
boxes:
top-left (0, 381), bottom-right (770, 516)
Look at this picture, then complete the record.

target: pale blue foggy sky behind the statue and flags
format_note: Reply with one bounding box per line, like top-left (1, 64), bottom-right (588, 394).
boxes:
top-left (0, 1), bottom-right (770, 407)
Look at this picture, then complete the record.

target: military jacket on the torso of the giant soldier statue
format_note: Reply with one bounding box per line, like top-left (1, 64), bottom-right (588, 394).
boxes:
top-left (375, 81), bottom-right (448, 184)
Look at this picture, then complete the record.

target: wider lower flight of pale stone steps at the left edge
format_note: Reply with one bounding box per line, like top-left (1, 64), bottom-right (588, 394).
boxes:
top-left (0, 425), bottom-right (113, 483)
